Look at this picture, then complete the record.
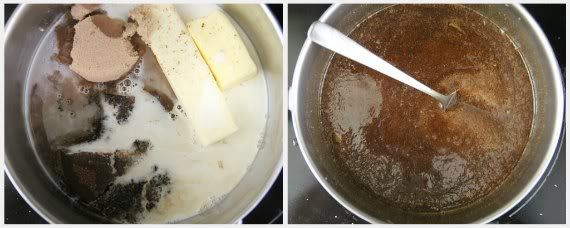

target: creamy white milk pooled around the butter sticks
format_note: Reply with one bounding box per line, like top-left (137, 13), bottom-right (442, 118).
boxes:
top-left (27, 5), bottom-right (267, 223)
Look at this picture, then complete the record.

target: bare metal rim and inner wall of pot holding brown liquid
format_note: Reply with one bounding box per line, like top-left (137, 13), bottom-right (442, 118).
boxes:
top-left (289, 5), bottom-right (564, 223)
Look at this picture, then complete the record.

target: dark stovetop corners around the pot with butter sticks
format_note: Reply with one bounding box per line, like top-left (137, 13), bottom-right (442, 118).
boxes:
top-left (4, 4), bottom-right (283, 224)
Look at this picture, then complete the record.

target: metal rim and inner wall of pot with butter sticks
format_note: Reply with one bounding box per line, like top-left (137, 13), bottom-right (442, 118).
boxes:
top-left (4, 4), bottom-right (283, 223)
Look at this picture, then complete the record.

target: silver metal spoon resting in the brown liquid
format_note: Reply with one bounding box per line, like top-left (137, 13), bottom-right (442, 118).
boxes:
top-left (308, 21), bottom-right (457, 110)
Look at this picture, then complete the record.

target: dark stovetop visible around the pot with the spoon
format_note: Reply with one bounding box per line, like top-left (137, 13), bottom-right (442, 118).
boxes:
top-left (288, 4), bottom-right (566, 224)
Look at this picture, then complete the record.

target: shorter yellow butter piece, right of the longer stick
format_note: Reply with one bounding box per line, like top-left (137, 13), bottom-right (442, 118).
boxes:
top-left (187, 10), bottom-right (257, 90)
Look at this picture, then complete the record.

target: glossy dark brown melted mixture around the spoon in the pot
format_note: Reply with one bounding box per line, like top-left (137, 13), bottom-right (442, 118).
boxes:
top-left (321, 5), bottom-right (533, 212)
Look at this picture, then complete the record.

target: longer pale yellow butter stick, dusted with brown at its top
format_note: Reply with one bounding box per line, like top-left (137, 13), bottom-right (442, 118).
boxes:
top-left (129, 5), bottom-right (238, 146)
